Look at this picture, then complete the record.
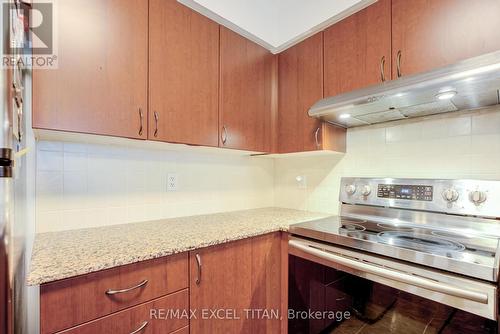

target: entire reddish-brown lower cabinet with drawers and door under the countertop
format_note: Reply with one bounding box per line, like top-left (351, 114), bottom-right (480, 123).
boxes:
top-left (40, 232), bottom-right (288, 334)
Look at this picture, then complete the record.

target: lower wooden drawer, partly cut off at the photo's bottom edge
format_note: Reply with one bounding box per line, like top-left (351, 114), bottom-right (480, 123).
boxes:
top-left (61, 289), bottom-right (189, 334)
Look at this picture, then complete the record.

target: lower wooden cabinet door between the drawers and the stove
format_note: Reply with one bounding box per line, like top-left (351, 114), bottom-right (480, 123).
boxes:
top-left (190, 233), bottom-right (281, 334)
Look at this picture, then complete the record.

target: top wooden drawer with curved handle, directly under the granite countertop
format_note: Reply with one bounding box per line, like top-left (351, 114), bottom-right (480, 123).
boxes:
top-left (40, 253), bottom-right (188, 334)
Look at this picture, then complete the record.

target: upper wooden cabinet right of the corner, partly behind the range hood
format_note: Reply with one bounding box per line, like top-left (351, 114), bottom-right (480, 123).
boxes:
top-left (278, 33), bottom-right (345, 153)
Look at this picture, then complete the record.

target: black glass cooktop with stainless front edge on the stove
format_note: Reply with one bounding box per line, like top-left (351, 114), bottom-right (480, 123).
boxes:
top-left (290, 217), bottom-right (499, 281)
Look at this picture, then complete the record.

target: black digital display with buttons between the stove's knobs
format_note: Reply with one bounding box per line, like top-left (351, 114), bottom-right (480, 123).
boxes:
top-left (377, 184), bottom-right (433, 202)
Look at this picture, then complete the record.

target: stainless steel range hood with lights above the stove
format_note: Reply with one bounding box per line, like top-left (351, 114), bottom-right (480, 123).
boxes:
top-left (309, 51), bottom-right (500, 128)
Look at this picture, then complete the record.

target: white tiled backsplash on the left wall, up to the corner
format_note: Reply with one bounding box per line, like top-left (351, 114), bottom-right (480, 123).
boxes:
top-left (36, 145), bottom-right (274, 233)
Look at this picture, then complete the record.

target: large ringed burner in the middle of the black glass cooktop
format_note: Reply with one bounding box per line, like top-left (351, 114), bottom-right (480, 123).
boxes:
top-left (377, 231), bottom-right (465, 252)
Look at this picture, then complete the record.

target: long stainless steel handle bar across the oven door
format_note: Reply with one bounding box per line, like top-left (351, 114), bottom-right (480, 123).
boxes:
top-left (288, 240), bottom-right (488, 304)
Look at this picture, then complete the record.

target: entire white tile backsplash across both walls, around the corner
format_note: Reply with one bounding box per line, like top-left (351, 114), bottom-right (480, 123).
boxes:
top-left (36, 108), bottom-right (500, 232)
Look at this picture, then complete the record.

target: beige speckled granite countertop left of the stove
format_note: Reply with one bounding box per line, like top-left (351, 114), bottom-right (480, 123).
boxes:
top-left (28, 208), bottom-right (329, 285)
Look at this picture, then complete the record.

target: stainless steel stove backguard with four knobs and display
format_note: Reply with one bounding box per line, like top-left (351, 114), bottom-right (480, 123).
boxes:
top-left (340, 177), bottom-right (500, 219)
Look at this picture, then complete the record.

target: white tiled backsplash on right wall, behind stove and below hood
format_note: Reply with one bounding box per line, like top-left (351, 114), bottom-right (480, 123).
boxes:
top-left (275, 107), bottom-right (500, 214)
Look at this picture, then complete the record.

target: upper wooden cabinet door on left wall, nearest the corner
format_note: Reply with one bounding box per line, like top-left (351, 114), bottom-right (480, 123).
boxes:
top-left (219, 27), bottom-right (277, 152)
